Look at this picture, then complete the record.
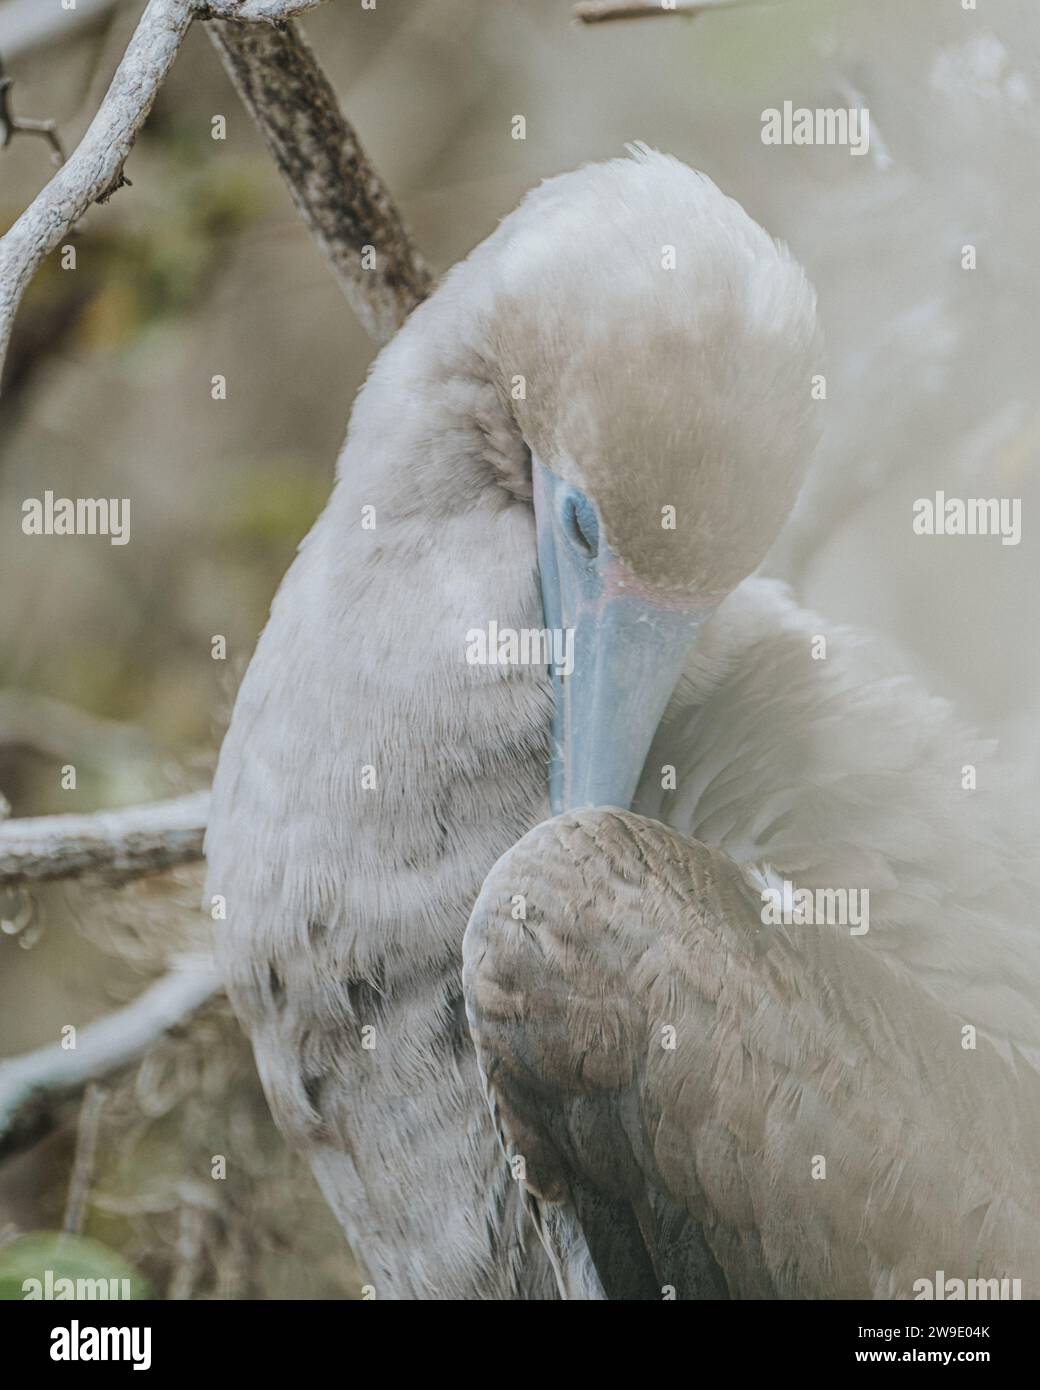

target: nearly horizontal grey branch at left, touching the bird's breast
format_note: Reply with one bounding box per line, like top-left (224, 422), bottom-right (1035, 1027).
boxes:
top-left (0, 791), bottom-right (210, 888)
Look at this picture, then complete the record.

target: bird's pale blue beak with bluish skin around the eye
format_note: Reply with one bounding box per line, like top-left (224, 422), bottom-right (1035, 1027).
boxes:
top-left (534, 460), bottom-right (712, 815)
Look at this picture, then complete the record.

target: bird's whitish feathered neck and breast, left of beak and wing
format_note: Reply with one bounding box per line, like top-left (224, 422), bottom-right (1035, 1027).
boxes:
top-left (207, 296), bottom-right (551, 1298)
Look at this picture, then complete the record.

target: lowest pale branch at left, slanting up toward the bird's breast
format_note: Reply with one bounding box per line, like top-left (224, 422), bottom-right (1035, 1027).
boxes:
top-left (0, 963), bottom-right (220, 1159)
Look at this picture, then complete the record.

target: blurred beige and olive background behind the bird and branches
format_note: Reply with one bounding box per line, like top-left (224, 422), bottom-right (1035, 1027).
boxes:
top-left (0, 0), bottom-right (1040, 1298)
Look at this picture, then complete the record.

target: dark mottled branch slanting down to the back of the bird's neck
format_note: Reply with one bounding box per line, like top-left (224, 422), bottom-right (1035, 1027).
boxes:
top-left (209, 18), bottom-right (432, 343)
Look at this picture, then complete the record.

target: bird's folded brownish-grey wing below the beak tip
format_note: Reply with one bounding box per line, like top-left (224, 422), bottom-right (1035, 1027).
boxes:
top-left (464, 810), bottom-right (1040, 1298)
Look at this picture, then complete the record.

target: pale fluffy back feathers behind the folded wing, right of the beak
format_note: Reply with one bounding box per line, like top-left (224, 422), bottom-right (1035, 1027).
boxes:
top-left (634, 580), bottom-right (1040, 1061)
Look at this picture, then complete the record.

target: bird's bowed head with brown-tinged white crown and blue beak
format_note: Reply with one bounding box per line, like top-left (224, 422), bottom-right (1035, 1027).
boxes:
top-left (489, 150), bottom-right (819, 812)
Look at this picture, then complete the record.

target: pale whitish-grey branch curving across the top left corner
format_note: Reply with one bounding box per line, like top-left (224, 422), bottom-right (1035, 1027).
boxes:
top-left (0, 0), bottom-right (193, 378)
